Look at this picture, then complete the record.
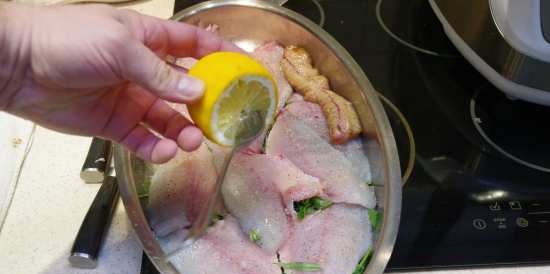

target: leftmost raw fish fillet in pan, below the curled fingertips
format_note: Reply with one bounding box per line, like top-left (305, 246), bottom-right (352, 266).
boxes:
top-left (147, 144), bottom-right (223, 237)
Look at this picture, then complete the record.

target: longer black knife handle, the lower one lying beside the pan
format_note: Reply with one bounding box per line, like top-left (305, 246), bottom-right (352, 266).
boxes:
top-left (69, 167), bottom-right (119, 269)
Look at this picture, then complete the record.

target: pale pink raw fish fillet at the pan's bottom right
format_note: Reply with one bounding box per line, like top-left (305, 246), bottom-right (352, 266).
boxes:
top-left (279, 204), bottom-right (372, 274)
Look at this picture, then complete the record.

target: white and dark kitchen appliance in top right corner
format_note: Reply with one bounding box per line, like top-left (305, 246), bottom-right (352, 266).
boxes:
top-left (430, 0), bottom-right (550, 106)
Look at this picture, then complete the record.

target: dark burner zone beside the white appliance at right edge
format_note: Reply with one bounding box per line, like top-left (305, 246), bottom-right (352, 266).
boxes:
top-left (470, 84), bottom-right (550, 173)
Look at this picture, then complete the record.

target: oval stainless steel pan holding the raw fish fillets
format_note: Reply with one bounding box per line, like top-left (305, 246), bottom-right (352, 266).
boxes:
top-left (115, 0), bottom-right (401, 274)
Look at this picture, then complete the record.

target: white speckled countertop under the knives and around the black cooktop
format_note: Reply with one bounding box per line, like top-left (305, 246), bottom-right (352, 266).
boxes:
top-left (0, 0), bottom-right (550, 274)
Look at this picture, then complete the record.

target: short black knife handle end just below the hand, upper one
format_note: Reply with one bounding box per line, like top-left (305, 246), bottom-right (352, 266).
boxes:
top-left (80, 137), bottom-right (112, 183)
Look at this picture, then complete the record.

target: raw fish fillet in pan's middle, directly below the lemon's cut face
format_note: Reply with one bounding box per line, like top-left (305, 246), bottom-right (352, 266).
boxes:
top-left (222, 153), bottom-right (322, 253)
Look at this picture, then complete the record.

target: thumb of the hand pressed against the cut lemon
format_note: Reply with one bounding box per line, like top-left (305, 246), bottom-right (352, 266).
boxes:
top-left (121, 41), bottom-right (204, 103)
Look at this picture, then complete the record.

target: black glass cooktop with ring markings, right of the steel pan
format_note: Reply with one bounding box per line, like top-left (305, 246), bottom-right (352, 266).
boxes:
top-left (143, 0), bottom-right (550, 271)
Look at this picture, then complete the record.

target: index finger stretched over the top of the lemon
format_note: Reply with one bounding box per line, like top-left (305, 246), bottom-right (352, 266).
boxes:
top-left (118, 10), bottom-right (242, 58)
